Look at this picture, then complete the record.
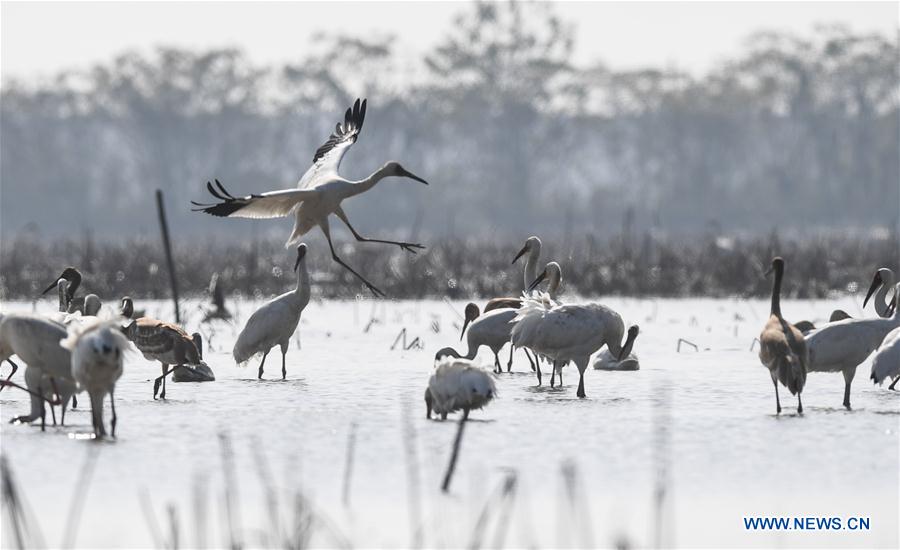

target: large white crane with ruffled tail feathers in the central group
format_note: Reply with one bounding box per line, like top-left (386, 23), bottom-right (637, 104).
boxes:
top-left (512, 298), bottom-right (639, 397)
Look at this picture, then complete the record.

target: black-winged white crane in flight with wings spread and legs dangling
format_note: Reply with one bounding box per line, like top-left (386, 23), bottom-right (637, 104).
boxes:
top-left (193, 99), bottom-right (428, 296)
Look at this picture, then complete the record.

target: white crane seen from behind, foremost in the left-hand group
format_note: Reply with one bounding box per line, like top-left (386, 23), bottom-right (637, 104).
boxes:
top-left (60, 321), bottom-right (128, 437)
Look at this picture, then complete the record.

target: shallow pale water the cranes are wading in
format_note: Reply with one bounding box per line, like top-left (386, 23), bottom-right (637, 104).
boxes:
top-left (0, 299), bottom-right (900, 548)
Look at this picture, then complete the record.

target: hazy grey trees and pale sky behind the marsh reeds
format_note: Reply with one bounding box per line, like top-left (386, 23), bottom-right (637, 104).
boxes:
top-left (0, 2), bottom-right (900, 300)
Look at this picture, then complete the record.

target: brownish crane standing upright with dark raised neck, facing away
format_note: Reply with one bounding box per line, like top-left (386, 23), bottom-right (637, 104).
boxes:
top-left (759, 257), bottom-right (809, 414)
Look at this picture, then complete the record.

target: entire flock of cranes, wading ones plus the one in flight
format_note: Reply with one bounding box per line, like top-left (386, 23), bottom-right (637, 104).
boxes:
top-left (0, 100), bottom-right (900, 437)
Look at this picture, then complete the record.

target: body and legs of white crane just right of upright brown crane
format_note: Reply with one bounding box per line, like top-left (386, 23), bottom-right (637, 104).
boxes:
top-left (806, 284), bottom-right (900, 410)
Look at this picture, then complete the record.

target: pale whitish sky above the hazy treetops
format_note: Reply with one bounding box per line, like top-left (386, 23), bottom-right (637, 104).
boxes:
top-left (0, 2), bottom-right (898, 79)
